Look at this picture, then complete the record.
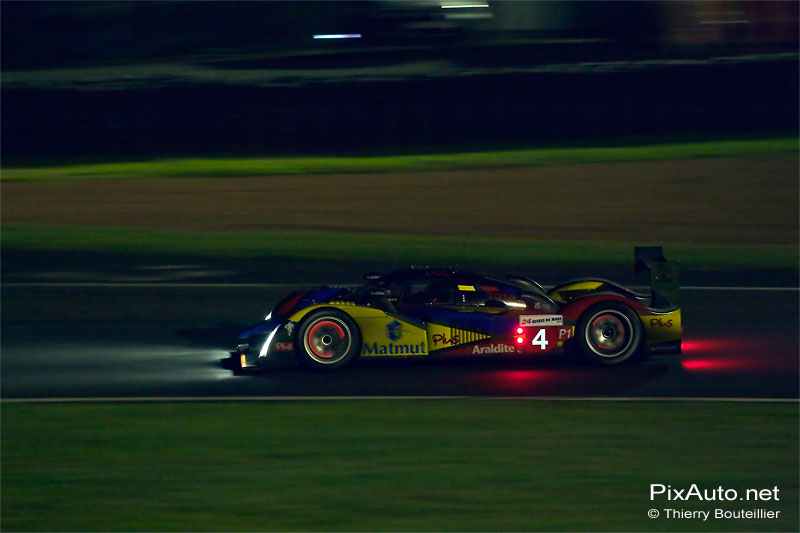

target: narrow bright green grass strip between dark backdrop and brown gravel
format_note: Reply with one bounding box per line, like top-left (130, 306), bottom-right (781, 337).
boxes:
top-left (0, 138), bottom-right (798, 181)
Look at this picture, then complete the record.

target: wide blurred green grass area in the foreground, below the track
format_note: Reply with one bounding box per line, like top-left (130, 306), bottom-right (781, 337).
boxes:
top-left (1, 402), bottom-right (798, 531)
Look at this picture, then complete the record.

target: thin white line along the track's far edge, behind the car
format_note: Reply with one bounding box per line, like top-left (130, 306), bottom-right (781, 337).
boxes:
top-left (0, 281), bottom-right (800, 292)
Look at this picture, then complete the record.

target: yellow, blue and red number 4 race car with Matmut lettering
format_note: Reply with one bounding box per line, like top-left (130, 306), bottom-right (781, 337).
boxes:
top-left (232, 247), bottom-right (683, 370)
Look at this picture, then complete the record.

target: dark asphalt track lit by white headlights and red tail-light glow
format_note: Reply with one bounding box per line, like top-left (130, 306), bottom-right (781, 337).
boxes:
top-left (0, 278), bottom-right (798, 398)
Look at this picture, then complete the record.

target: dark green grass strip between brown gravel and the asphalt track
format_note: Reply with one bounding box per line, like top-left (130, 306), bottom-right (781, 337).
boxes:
top-left (2, 225), bottom-right (798, 269)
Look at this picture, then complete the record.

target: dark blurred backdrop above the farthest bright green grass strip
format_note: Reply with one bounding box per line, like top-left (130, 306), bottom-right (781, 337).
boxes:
top-left (2, 1), bottom-right (798, 161)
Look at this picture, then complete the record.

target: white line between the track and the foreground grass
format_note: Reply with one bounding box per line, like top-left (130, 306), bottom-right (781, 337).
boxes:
top-left (0, 396), bottom-right (800, 404)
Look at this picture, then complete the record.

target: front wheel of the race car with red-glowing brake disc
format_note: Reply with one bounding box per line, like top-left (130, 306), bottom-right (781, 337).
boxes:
top-left (295, 309), bottom-right (361, 371)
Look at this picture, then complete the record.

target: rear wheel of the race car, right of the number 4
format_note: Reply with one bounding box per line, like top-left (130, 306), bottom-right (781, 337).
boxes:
top-left (575, 302), bottom-right (644, 365)
